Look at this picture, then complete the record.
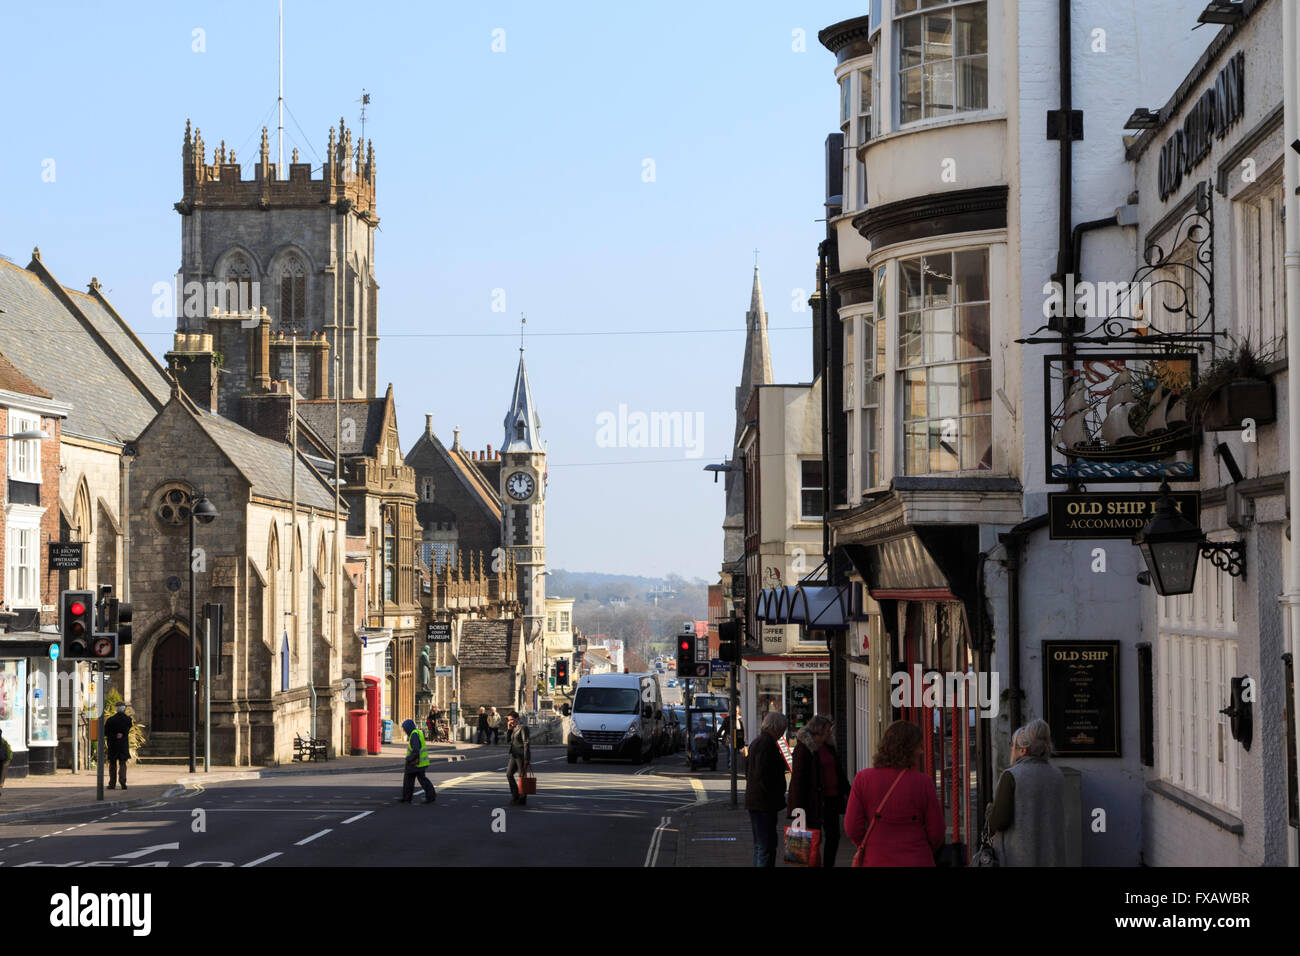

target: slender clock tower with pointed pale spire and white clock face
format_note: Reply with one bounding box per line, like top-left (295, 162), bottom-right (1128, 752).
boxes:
top-left (501, 347), bottom-right (546, 639)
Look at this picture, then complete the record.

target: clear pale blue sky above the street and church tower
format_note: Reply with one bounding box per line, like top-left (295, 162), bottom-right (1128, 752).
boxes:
top-left (0, 0), bottom-right (867, 580)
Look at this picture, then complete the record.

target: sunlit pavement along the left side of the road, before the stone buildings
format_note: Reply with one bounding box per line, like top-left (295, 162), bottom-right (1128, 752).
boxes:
top-left (0, 743), bottom-right (475, 823)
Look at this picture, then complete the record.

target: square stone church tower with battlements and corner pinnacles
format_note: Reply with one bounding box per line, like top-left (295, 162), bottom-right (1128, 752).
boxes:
top-left (169, 120), bottom-right (380, 420)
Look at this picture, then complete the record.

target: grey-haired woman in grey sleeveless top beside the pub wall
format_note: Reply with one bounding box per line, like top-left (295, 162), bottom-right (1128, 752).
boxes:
top-left (988, 721), bottom-right (1065, 866)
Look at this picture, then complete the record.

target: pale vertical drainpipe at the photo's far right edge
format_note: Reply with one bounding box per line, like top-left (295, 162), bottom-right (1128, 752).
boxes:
top-left (1282, 3), bottom-right (1300, 865)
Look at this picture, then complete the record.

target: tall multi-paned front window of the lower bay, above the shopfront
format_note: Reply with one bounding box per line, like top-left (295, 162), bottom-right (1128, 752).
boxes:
top-left (897, 248), bottom-right (993, 475)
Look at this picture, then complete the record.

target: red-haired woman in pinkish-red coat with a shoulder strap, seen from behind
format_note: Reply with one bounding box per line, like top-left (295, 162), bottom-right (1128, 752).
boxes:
top-left (844, 721), bottom-right (944, 866)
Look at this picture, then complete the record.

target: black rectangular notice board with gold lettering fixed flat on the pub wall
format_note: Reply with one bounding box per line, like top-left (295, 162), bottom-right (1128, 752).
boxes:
top-left (1043, 641), bottom-right (1122, 757)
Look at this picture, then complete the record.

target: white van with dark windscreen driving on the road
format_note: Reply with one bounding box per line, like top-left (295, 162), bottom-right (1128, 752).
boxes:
top-left (566, 674), bottom-right (663, 763)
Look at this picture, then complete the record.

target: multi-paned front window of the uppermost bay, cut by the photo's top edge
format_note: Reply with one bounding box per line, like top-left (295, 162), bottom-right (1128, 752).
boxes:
top-left (893, 0), bottom-right (988, 124)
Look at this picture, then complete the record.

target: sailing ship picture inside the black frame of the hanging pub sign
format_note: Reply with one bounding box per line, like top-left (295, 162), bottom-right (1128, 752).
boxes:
top-left (1052, 359), bottom-right (1196, 477)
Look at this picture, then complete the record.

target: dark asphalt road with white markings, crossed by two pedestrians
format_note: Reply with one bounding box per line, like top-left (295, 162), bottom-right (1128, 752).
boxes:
top-left (0, 748), bottom-right (725, 869)
